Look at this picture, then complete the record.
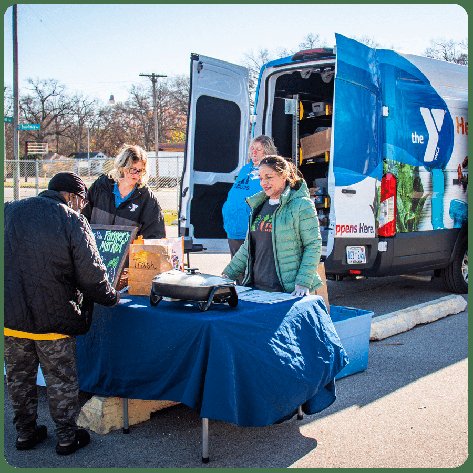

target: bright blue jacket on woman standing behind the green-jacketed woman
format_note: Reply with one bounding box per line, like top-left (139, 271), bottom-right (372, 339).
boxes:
top-left (222, 161), bottom-right (261, 240)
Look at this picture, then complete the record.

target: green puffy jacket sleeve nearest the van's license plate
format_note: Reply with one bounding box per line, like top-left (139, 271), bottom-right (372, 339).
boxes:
top-left (295, 199), bottom-right (322, 289)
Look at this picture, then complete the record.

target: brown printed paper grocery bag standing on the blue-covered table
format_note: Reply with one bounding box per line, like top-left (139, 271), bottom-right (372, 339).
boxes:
top-left (128, 241), bottom-right (173, 296)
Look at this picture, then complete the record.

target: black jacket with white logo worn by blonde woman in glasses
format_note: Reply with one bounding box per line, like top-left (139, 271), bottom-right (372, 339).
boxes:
top-left (82, 175), bottom-right (166, 238)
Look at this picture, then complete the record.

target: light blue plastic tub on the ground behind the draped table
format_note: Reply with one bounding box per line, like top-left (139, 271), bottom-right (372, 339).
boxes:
top-left (330, 305), bottom-right (373, 379)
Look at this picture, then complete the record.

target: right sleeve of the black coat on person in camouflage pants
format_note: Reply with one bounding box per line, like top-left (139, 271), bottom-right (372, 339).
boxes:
top-left (70, 216), bottom-right (118, 306)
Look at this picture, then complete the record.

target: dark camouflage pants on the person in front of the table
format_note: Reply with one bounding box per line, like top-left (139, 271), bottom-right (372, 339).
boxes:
top-left (5, 337), bottom-right (80, 443)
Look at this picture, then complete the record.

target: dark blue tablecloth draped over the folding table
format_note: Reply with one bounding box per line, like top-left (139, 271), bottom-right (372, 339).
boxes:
top-left (77, 296), bottom-right (347, 426)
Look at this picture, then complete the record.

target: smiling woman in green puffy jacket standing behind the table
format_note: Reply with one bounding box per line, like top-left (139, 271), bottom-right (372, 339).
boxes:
top-left (223, 156), bottom-right (322, 296)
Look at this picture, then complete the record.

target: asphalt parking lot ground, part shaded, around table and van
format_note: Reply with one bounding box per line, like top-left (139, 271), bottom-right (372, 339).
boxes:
top-left (2, 227), bottom-right (468, 471)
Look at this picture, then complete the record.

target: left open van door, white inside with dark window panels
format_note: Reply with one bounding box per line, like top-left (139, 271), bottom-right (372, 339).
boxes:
top-left (179, 54), bottom-right (250, 249)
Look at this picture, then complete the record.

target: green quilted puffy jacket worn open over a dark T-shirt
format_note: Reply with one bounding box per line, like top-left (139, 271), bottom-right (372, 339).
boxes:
top-left (223, 181), bottom-right (322, 292)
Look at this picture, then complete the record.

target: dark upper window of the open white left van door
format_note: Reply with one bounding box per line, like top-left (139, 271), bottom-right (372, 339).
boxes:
top-left (194, 95), bottom-right (241, 173)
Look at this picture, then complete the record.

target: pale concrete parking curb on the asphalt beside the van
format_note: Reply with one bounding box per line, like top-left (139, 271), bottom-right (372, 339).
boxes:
top-left (370, 294), bottom-right (468, 340)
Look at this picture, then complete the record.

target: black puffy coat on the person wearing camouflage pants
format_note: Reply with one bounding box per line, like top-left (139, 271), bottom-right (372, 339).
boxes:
top-left (4, 190), bottom-right (117, 335)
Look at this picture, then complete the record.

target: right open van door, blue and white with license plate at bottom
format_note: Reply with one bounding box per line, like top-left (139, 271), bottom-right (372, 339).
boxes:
top-left (326, 34), bottom-right (383, 274)
